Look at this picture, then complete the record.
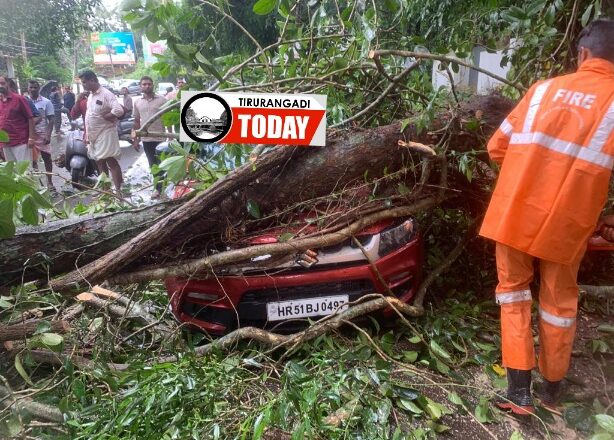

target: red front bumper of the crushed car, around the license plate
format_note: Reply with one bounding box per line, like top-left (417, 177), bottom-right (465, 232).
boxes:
top-left (165, 236), bottom-right (423, 335)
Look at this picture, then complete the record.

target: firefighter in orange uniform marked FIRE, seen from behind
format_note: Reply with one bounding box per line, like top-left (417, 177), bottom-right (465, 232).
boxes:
top-left (480, 19), bottom-right (614, 415)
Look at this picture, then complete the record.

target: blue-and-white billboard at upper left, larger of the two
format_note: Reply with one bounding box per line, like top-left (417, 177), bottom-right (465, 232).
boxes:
top-left (91, 32), bottom-right (136, 64)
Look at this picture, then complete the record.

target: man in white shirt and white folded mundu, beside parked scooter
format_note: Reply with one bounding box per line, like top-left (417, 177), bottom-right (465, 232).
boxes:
top-left (79, 70), bottom-right (124, 196)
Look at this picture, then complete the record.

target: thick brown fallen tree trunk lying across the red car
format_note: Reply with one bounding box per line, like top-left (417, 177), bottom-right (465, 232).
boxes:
top-left (0, 95), bottom-right (510, 291)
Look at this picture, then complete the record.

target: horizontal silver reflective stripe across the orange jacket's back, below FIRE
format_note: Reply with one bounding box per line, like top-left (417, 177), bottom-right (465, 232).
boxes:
top-left (510, 131), bottom-right (614, 170)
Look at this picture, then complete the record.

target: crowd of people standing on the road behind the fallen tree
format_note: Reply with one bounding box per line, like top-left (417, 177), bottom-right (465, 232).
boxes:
top-left (0, 70), bottom-right (185, 199)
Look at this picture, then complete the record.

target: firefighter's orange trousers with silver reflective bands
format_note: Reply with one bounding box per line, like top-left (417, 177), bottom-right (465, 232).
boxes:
top-left (496, 243), bottom-right (580, 381)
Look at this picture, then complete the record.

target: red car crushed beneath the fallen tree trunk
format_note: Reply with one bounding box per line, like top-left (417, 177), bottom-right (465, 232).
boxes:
top-left (165, 218), bottom-right (423, 335)
